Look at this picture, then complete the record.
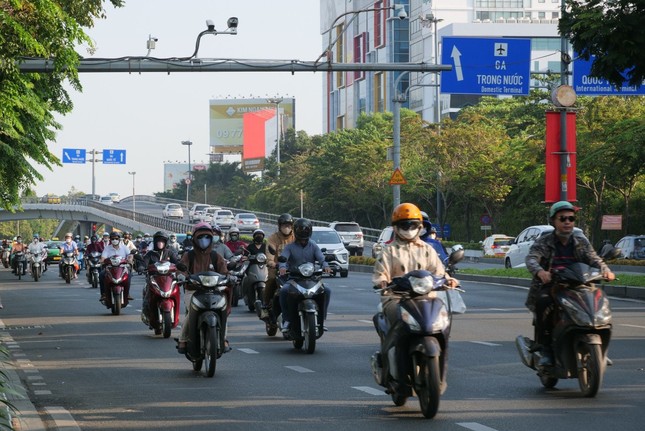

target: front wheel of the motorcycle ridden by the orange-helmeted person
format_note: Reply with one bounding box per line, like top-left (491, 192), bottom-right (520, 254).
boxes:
top-left (414, 354), bottom-right (441, 419)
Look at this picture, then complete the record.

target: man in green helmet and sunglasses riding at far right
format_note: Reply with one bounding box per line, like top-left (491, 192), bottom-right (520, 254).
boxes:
top-left (525, 201), bottom-right (616, 366)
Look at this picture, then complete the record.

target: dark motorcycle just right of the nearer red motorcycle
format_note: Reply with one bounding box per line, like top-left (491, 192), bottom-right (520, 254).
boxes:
top-left (175, 271), bottom-right (234, 377)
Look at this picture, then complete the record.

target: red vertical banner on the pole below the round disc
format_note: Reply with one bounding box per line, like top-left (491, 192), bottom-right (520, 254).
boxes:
top-left (544, 111), bottom-right (577, 202)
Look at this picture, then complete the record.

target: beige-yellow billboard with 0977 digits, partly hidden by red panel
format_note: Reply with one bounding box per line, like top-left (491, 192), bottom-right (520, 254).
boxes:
top-left (209, 98), bottom-right (296, 154)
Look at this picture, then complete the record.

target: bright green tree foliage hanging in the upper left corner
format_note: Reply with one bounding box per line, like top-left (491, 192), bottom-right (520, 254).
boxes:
top-left (0, 0), bottom-right (123, 209)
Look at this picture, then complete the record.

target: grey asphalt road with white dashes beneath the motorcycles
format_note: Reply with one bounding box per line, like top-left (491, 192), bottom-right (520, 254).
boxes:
top-left (0, 269), bottom-right (645, 431)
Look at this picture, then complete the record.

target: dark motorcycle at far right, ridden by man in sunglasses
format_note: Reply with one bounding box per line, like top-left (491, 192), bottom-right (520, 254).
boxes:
top-left (515, 263), bottom-right (612, 397)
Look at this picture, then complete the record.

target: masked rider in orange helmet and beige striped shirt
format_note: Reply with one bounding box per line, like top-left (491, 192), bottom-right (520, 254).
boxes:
top-left (372, 203), bottom-right (459, 394)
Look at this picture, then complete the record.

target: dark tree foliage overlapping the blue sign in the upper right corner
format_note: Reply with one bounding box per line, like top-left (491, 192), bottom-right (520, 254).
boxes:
top-left (558, 0), bottom-right (645, 88)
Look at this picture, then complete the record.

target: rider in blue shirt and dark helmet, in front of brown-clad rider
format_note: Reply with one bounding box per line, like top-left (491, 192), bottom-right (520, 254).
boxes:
top-left (278, 218), bottom-right (331, 332)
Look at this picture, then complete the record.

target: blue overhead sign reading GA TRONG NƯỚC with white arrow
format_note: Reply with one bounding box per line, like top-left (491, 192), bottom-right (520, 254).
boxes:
top-left (441, 37), bottom-right (531, 96)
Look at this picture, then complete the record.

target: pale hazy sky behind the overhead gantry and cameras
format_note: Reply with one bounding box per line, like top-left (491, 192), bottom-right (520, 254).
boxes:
top-left (35, 0), bottom-right (323, 196)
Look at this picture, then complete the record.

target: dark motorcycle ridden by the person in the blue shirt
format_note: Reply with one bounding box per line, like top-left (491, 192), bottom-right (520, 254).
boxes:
top-left (274, 256), bottom-right (331, 354)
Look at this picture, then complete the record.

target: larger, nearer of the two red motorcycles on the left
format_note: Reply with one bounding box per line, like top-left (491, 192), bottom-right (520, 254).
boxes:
top-left (141, 261), bottom-right (185, 338)
